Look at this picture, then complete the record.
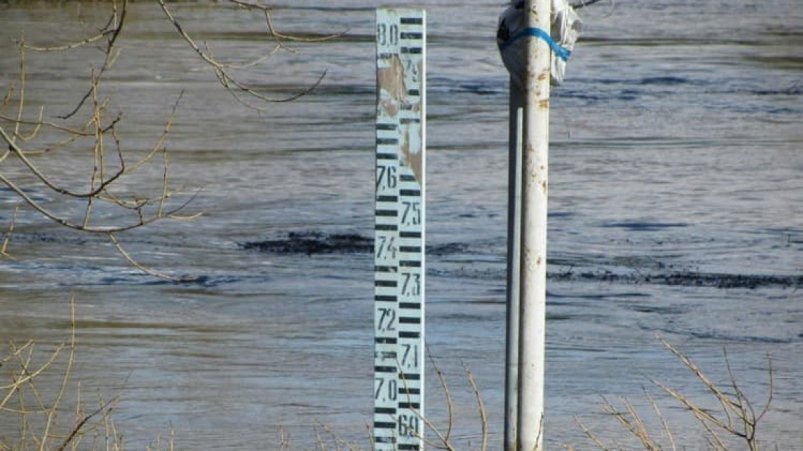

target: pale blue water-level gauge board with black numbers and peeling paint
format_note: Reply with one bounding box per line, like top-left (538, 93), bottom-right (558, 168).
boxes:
top-left (373, 9), bottom-right (426, 451)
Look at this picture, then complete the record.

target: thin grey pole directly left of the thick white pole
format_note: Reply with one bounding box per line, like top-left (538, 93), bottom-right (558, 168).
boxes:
top-left (505, 79), bottom-right (524, 451)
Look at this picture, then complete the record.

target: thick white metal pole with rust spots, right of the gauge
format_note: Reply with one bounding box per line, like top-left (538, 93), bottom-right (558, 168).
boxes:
top-left (518, 0), bottom-right (551, 451)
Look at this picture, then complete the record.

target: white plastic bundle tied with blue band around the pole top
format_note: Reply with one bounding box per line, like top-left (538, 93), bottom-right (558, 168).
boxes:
top-left (496, 0), bottom-right (583, 89)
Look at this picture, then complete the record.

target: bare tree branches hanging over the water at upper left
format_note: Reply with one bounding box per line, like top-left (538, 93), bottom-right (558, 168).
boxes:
top-left (0, 0), bottom-right (332, 280)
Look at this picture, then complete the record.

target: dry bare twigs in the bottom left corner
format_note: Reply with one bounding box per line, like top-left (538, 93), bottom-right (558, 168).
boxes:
top-left (0, 300), bottom-right (174, 451)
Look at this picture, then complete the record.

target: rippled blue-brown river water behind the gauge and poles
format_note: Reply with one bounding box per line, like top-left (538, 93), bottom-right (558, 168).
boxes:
top-left (0, 0), bottom-right (803, 449)
